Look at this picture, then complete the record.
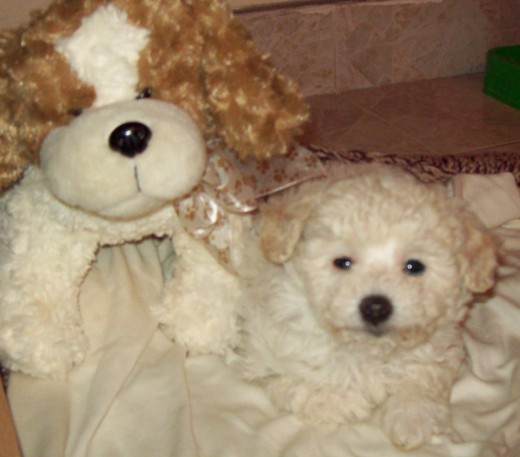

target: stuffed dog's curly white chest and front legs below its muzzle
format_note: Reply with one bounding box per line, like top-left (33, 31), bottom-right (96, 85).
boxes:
top-left (0, 169), bottom-right (237, 378)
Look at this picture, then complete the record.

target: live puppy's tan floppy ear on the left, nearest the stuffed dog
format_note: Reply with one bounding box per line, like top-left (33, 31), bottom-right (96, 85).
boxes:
top-left (260, 192), bottom-right (317, 263)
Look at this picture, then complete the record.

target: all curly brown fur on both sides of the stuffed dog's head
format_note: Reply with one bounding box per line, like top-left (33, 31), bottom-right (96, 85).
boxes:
top-left (0, 0), bottom-right (308, 189)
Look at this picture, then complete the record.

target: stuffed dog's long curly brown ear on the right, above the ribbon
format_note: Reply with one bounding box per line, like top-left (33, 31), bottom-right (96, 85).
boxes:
top-left (197, 0), bottom-right (308, 158)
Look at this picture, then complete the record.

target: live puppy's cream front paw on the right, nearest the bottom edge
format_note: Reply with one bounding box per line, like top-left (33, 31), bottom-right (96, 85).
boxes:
top-left (381, 396), bottom-right (449, 450)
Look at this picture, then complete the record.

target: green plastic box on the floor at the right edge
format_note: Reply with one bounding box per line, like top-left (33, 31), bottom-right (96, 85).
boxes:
top-left (484, 46), bottom-right (520, 109)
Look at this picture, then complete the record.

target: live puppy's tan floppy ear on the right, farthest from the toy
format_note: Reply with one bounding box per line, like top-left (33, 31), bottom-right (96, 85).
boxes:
top-left (458, 210), bottom-right (499, 293)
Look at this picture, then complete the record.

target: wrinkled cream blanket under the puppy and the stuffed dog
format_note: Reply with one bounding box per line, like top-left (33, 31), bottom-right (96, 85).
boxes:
top-left (9, 174), bottom-right (520, 457)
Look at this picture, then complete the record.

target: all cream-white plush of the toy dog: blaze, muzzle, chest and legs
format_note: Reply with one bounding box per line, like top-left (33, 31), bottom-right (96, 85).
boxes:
top-left (0, 4), bottom-right (250, 378)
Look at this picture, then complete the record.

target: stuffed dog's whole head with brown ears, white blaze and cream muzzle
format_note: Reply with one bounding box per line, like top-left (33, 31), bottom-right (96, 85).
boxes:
top-left (0, 0), bottom-right (307, 218)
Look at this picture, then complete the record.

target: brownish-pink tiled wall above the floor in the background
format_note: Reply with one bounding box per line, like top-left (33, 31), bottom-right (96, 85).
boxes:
top-left (239, 0), bottom-right (520, 95)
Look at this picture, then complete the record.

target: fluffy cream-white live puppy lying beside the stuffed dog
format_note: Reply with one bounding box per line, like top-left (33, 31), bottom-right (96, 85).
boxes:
top-left (239, 164), bottom-right (496, 449)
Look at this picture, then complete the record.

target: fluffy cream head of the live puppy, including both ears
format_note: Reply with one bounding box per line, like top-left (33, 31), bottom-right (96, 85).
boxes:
top-left (261, 166), bottom-right (496, 340)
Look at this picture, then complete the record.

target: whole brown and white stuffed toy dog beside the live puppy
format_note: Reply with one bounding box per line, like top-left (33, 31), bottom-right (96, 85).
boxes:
top-left (0, 0), bottom-right (307, 378)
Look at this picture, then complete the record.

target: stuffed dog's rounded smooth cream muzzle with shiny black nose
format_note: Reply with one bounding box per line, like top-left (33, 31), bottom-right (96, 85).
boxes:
top-left (40, 99), bottom-right (207, 219)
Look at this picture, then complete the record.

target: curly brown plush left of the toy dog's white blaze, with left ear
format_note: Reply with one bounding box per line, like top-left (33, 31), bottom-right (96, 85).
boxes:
top-left (0, 0), bottom-right (97, 191)
